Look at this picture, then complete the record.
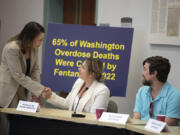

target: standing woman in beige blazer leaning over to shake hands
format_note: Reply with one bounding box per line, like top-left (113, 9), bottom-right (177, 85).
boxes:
top-left (0, 22), bottom-right (51, 107)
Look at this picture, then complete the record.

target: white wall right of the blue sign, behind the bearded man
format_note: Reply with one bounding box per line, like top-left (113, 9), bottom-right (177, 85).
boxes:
top-left (97, 0), bottom-right (180, 114)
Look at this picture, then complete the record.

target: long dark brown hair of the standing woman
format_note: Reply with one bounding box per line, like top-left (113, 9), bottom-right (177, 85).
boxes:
top-left (8, 22), bottom-right (45, 54)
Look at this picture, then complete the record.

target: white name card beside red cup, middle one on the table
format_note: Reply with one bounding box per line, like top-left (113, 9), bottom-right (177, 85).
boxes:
top-left (99, 112), bottom-right (129, 125)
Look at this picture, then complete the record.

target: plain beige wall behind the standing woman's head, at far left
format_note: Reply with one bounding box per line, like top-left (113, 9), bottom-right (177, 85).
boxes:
top-left (0, 0), bottom-right (44, 68)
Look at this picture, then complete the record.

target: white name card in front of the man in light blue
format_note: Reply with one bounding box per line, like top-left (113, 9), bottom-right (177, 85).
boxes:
top-left (145, 119), bottom-right (169, 133)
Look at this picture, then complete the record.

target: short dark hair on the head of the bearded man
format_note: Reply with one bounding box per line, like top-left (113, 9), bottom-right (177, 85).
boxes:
top-left (143, 56), bottom-right (171, 82)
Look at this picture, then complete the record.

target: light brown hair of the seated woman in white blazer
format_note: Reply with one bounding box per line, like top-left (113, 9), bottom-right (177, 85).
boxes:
top-left (86, 58), bottom-right (104, 82)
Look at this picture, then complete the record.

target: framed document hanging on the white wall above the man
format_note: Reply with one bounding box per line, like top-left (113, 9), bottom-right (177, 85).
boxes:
top-left (149, 0), bottom-right (180, 45)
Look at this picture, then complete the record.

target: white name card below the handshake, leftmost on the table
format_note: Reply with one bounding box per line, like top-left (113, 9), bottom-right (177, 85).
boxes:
top-left (16, 100), bottom-right (40, 113)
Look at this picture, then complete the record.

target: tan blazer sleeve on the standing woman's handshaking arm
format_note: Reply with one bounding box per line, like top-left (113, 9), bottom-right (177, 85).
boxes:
top-left (5, 44), bottom-right (44, 96)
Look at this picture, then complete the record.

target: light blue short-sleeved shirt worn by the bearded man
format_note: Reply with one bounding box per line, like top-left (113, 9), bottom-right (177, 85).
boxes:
top-left (134, 82), bottom-right (180, 120)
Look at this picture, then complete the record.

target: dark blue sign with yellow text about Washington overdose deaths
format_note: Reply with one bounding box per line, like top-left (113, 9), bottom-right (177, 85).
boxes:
top-left (42, 24), bottom-right (133, 97)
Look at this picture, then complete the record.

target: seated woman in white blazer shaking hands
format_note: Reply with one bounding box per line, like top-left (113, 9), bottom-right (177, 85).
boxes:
top-left (47, 58), bottom-right (110, 113)
